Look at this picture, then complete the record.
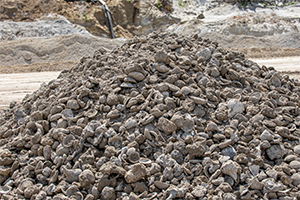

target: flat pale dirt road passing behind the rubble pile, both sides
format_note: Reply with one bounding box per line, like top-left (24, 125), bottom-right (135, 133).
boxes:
top-left (0, 57), bottom-right (300, 110)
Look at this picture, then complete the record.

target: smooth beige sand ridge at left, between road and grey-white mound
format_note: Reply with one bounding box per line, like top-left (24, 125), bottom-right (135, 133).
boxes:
top-left (0, 34), bottom-right (124, 70)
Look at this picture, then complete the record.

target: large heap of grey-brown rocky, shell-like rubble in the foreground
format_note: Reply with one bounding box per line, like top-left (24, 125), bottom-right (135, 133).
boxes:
top-left (0, 32), bottom-right (300, 200)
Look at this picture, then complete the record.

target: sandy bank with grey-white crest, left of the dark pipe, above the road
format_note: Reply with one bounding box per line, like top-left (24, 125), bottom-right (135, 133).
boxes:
top-left (0, 16), bottom-right (126, 73)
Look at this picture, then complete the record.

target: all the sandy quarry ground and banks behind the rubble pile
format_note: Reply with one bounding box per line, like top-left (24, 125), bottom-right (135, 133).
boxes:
top-left (0, 0), bottom-right (300, 109)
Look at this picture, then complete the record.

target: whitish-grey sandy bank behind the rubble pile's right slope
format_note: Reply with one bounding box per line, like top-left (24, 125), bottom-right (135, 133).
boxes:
top-left (167, 1), bottom-right (300, 58)
